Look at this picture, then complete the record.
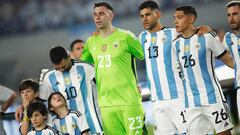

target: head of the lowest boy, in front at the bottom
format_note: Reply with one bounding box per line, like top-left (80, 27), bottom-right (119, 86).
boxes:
top-left (27, 102), bottom-right (48, 128)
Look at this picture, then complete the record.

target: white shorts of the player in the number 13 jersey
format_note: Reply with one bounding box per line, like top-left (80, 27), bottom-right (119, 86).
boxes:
top-left (153, 99), bottom-right (186, 135)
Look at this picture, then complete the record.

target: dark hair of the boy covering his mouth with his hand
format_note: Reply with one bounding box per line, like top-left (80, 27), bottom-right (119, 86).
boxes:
top-left (18, 79), bottom-right (39, 93)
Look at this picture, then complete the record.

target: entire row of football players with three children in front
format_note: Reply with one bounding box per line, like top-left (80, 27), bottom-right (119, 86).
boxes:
top-left (7, 0), bottom-right (240, 135)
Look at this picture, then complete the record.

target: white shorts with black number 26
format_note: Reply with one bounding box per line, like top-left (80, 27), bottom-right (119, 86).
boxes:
top-left (186, 103), bottom-right (233, 135)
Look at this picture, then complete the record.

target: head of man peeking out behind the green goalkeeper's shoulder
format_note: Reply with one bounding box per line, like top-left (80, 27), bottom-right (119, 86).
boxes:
top-left (70, 39), bottom-right (84, 60)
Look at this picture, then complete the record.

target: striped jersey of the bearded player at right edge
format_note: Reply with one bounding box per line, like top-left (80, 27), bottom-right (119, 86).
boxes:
top-left (223, 32), bottom-right (240, 89)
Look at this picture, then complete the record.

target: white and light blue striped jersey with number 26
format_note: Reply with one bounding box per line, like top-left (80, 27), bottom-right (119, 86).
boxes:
top-left (173, 32), bottom-right (227, 107)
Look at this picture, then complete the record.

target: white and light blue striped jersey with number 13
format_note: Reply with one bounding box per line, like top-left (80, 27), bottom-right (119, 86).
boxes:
top-left (139, 28), bottom-right (184, 101)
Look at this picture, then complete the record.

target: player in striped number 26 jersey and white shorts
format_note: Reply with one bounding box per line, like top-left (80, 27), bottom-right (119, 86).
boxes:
top-left (173, 6), bottom-right (234, 135)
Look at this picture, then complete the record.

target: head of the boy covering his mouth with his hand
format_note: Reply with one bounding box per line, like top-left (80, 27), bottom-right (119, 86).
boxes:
top-left (19, 79), bottom-right (39, 102)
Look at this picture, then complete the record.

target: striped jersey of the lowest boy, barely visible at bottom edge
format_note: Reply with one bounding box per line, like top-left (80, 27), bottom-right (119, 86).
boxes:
top-left (27, 126), bottom-right (58, 135)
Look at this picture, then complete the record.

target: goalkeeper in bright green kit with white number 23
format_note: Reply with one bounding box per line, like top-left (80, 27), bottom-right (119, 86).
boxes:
top-left (81, 2), bottom-right (144, 135)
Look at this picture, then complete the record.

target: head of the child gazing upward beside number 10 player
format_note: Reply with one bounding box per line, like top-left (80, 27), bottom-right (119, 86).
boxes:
top-left (48, 92), bottom-right (67, 113)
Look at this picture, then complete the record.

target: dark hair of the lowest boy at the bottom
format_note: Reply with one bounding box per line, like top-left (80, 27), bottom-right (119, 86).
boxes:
top-left (27, 102), bottom-right (48, 118)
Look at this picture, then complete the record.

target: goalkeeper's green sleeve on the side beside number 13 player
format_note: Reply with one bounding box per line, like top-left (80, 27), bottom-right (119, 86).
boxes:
top-left (127, 33), bottom-right (144, 60)
